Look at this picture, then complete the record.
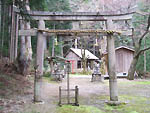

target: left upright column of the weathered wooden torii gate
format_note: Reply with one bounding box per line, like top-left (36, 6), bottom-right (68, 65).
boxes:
top-left (34, 20), bottom-right (45, 102)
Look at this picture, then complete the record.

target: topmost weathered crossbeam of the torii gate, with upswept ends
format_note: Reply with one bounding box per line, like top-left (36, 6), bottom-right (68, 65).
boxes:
top-left (19, 11), bottom-right (134, 21)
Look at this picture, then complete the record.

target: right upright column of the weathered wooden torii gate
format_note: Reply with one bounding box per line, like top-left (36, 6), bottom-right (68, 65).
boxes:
top-left (107, 20), bottom-right (118, 101)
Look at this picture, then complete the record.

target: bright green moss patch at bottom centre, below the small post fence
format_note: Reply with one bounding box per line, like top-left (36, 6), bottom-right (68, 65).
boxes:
top-left (56, 105), bottom-right (104, 113)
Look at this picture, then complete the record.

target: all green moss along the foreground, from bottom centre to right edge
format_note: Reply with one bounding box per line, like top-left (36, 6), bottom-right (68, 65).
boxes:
top-left (56, 95), bottom-right (150, 113)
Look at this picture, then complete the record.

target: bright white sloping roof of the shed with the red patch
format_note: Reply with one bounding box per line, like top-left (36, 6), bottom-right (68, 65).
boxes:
top-left (70, 48), bottom-right (99, 60)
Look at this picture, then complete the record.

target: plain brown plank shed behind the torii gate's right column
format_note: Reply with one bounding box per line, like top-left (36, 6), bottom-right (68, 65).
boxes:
top-left (104, 46), bottom-right (134, 73)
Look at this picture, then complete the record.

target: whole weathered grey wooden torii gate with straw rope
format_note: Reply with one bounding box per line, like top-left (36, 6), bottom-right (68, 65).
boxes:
top-left (19, 11), bottom-right (134, 101)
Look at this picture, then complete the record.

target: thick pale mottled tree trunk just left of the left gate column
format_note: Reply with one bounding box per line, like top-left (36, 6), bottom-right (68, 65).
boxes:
top-left (16, 0), bottom-right (32, 76)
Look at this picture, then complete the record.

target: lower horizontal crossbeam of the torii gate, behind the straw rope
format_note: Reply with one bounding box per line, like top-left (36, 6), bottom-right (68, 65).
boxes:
top-left (19, 29), bottom-right (132, 36)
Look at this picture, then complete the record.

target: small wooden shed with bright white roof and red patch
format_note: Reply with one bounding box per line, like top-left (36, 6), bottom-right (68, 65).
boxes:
top-left (65, 48), bottom-right (99, 73)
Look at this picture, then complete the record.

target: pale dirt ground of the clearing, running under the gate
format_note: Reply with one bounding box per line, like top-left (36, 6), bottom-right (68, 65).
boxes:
top-left (0, 76), bottom-right (150, 113)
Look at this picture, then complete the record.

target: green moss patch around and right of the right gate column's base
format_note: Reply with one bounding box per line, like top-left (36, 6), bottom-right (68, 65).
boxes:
top-left (104, 95), bottom-right (150, 113)
